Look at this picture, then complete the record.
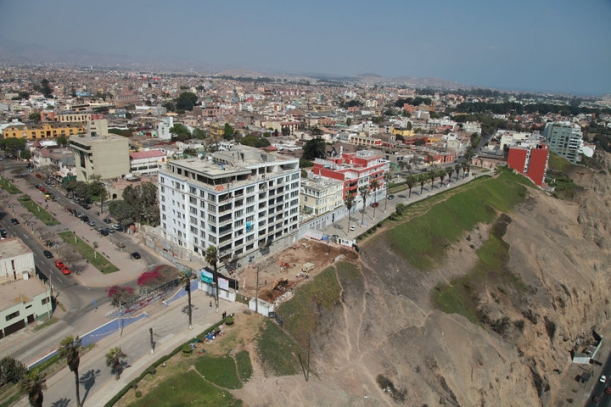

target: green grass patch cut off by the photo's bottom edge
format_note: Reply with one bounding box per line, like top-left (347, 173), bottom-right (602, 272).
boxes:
top-left (131, 370), bottom-right (242, 407)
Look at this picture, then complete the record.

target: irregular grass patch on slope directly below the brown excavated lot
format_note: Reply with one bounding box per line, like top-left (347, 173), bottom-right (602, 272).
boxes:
top-left (278, 267), bottom-right (341, 347)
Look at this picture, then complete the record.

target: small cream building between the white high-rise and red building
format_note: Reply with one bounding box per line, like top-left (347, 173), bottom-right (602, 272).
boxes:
top-left (299, 176), bottom-right (344, 216)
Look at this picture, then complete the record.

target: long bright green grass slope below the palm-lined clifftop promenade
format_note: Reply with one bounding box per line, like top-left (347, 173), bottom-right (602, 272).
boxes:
top-left (384, 171), bottom-right (526, 270)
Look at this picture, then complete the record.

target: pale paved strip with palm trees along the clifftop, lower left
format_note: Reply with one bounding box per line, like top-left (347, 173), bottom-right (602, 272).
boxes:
top-left (16, 291), bottom-right (246, 407)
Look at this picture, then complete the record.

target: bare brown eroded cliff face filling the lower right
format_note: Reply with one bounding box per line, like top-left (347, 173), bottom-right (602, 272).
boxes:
top-left (238, 157), bottom-right (611, 407)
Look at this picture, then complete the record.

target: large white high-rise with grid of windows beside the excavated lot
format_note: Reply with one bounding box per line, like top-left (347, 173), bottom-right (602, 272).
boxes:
top-left (159, 145), bottom-right (301, 261)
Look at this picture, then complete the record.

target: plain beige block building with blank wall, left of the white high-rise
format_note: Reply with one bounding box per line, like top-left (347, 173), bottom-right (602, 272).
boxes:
top-left (69, 134), bottom-right (129, 181)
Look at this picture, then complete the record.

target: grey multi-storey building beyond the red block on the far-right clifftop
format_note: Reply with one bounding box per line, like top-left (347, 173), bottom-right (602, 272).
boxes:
top-left (543, 122), bottom-right (583, 164)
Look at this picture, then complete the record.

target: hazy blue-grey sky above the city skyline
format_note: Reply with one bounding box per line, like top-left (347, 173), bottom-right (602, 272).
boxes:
top-left (0, 0), bottom-right (611, 94)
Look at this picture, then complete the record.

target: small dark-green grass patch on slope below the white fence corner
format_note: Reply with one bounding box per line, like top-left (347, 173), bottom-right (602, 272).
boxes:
top-left (257, 318), bottom-right (305, 376)
